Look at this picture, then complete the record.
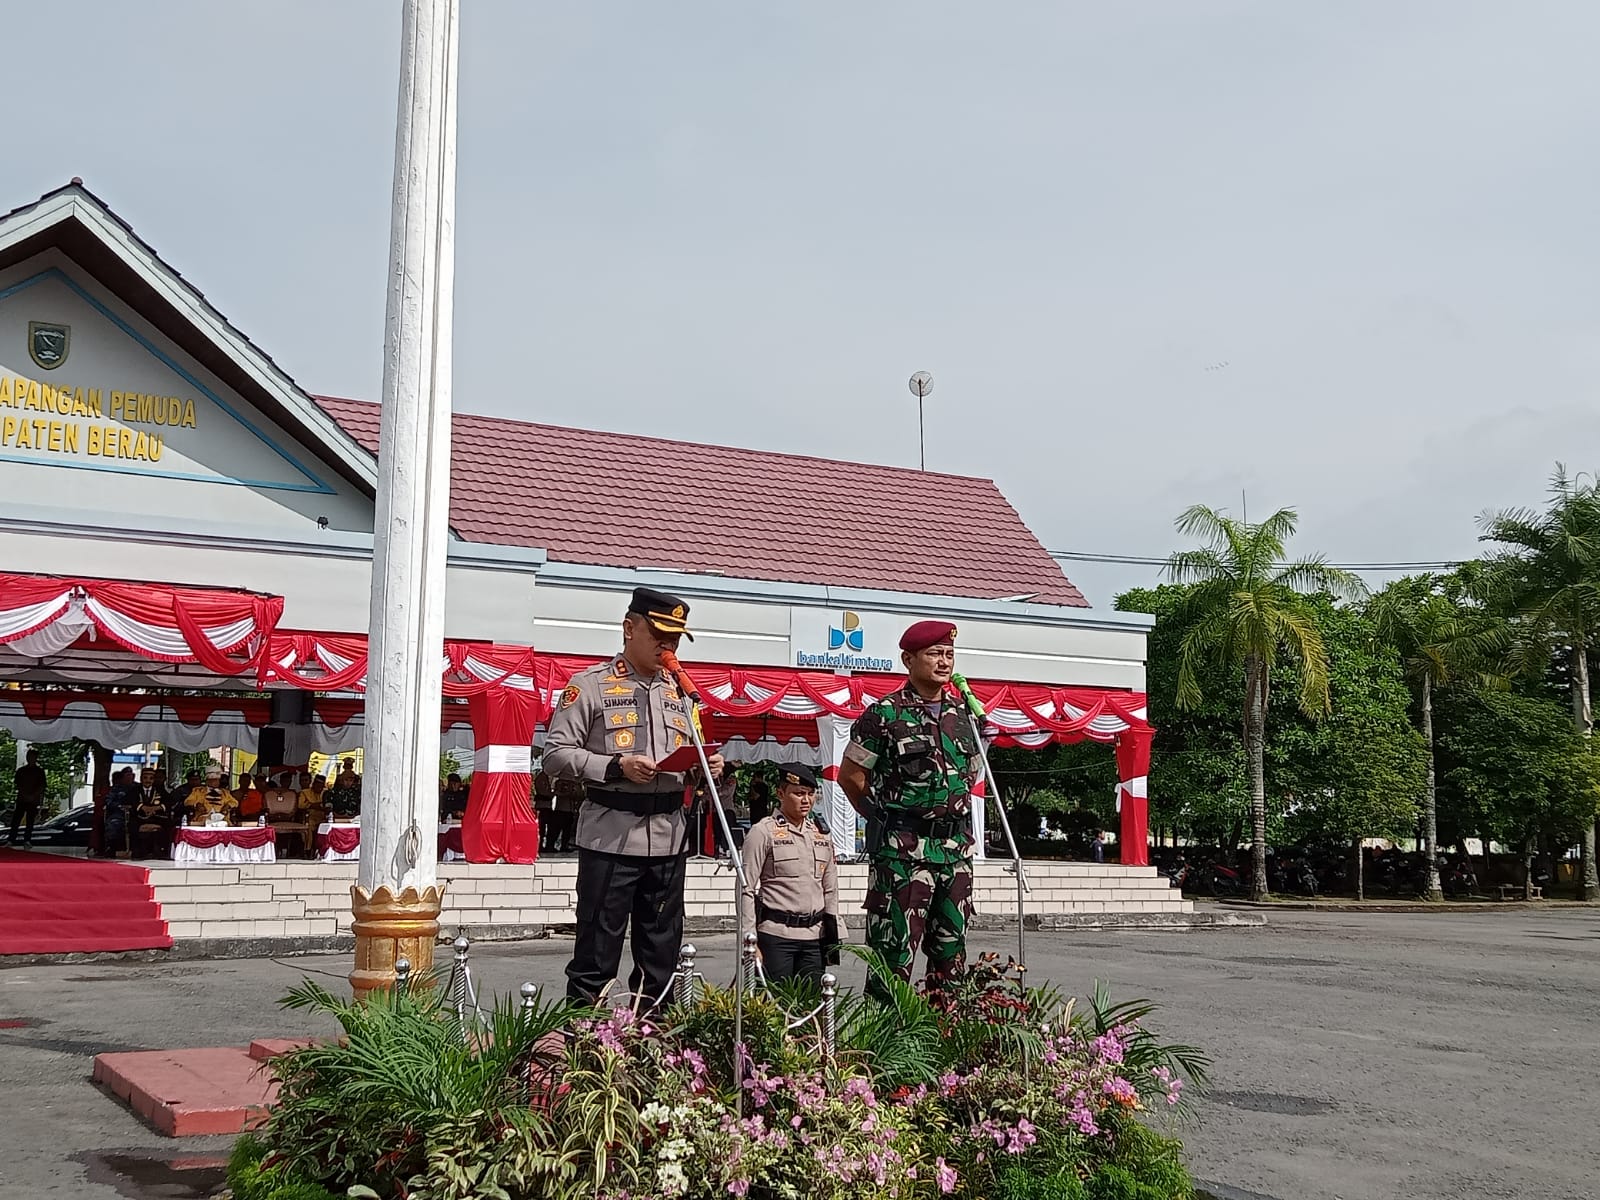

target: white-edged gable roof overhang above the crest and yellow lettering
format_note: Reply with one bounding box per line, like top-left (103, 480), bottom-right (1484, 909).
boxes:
top-left (0, 179), bottom-right (378, 493)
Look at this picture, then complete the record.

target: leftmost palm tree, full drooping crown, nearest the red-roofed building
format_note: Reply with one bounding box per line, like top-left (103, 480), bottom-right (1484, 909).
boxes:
top-left (1166, 504), bottom-right (1363, 899)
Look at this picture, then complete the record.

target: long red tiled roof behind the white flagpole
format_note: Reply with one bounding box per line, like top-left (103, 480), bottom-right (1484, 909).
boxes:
top-left (315, 397), bottom-right (1088, 606)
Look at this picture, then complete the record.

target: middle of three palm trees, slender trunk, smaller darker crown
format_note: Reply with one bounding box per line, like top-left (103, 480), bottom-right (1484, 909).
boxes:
top-left (1370, 574), bottom-right (1506, 901)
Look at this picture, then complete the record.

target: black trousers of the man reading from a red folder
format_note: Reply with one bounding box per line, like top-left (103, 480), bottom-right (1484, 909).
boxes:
top-left (566, 848), bottom-right (683, 1011)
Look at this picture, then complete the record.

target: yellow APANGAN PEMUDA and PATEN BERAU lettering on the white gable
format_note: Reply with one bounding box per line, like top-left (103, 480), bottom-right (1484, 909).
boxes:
top-left (0, 374), bottom-right (195, 462)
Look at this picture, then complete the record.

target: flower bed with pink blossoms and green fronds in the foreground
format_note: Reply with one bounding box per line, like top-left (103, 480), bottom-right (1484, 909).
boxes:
top-left (230, 958), bottom-right (1205, 1200)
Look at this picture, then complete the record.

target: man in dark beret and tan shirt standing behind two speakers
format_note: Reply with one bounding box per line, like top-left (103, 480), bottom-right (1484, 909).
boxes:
top-left (739, 765), bottom-right (838, 984)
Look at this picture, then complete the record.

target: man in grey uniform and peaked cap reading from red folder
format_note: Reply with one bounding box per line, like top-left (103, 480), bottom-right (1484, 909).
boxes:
top-left (544, 587), bottom-right (723, 1008)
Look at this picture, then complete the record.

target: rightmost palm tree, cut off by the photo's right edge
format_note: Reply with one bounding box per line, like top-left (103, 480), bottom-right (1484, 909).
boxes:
top-left (1483, 464), bottom-right (1600, 899)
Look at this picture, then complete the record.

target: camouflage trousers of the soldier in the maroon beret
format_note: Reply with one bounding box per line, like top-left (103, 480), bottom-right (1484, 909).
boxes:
top-left (866, 858), bottom-right (973, 992)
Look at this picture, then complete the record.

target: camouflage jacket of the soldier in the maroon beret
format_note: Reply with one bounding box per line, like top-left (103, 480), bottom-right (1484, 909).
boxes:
top-left (845, 683), bottom-right (982, 862)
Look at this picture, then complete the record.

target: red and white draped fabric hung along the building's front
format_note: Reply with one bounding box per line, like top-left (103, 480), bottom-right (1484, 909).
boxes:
top-left (0, 574), bottom-right (1152, 862)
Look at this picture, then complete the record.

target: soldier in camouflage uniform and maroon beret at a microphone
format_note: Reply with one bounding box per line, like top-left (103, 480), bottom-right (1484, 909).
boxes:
top-left (838, 621), bottom-right (982, 987)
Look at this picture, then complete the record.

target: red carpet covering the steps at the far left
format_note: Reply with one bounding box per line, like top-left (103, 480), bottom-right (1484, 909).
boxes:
top-left (0, 848), bottom-right (173, 954)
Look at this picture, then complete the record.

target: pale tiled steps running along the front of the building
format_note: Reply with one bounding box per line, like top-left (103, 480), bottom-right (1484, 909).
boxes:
top-left (150, 858), bottom-right (1194, 942)
